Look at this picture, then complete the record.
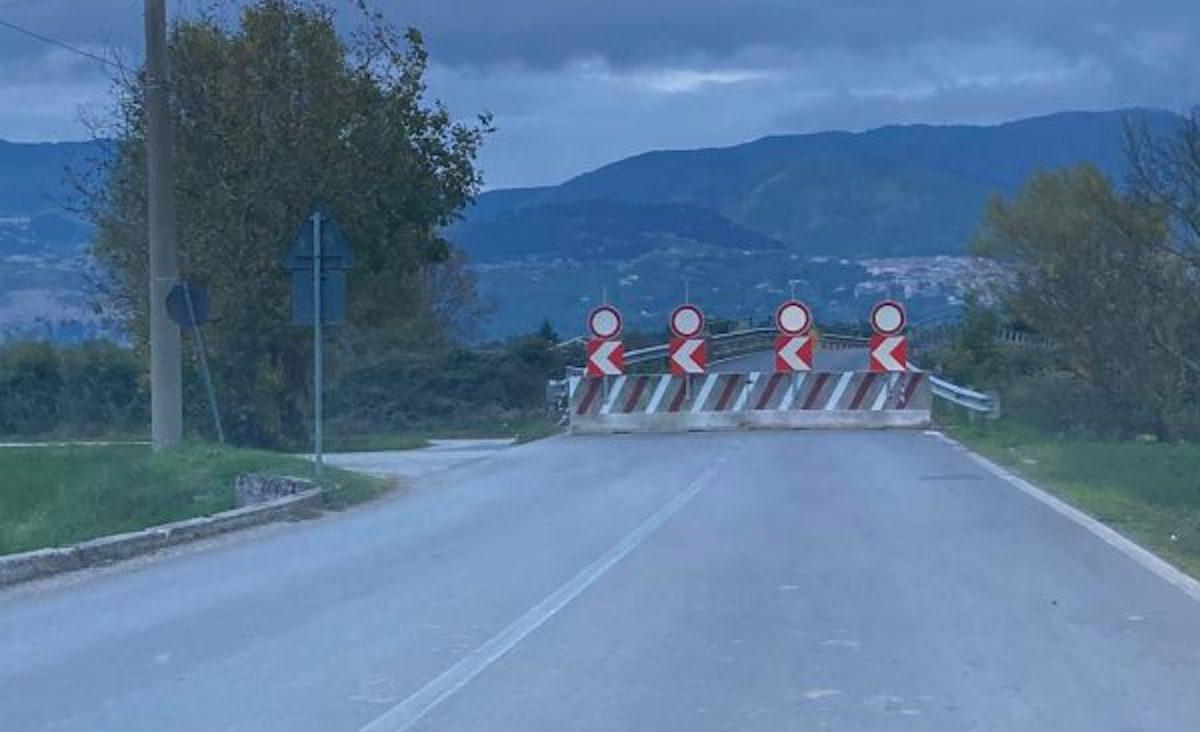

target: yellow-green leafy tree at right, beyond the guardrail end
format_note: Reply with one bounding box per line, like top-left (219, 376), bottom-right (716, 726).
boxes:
top-left (973, 164), bottom-right (1196, 437)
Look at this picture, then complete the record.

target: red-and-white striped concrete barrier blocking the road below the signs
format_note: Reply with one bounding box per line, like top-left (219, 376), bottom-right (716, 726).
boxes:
top-left (568, 371), bottom-right (931, 433)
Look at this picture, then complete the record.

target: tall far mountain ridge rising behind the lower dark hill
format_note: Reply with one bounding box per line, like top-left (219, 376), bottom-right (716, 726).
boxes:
top-left (462, 109), bottom-right (1178, 256)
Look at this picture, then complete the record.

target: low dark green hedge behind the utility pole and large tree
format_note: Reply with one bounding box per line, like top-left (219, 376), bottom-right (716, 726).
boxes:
top-left (0, 335), bottom-right (564, 448)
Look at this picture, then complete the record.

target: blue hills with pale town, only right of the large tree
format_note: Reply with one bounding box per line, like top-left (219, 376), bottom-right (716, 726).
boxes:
top-left (449, 109), bottom-right (1178, 332)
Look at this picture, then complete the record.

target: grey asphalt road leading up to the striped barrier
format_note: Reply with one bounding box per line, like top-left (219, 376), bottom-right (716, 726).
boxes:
top-left (0, 432), bottom-right (1200, 732)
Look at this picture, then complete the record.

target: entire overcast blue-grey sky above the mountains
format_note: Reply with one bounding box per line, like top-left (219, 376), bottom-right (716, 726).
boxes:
top-left (0, 0), bottom-right (1200, 187)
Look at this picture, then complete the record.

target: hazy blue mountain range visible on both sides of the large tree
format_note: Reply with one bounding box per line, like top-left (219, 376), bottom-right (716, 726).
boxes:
top-left (0, 109), bottom-right (1180, 337)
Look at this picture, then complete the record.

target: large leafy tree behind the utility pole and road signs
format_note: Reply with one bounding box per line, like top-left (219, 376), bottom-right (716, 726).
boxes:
top-left (89, 0), bottom-right (491, 444)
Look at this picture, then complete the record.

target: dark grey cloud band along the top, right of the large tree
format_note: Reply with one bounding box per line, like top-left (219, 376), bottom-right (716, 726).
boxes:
top-left (384, 0), bottom-right (1200, 66)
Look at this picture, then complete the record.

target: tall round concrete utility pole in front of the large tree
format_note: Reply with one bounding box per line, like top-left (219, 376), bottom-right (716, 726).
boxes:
top-left (145, 0), bottom-right (184, 450)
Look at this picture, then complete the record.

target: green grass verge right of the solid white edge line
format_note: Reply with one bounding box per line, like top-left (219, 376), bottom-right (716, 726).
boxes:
top-left (947, 412), bottom-right (1200, 577)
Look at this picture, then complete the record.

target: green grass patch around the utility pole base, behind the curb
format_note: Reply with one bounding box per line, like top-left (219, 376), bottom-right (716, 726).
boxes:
top-left (0, 444), bottom-right (392, 554)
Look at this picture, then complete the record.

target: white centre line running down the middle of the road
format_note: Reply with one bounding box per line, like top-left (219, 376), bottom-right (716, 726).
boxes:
top-left (359, 467), bottom-right (716, 732)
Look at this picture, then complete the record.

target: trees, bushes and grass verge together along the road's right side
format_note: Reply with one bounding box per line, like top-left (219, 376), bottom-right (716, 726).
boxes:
top-left (920, 108), bottom-right (1200, 577)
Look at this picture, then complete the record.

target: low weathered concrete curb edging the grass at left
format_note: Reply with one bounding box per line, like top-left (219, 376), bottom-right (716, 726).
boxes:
top-left (0, 488), bottom-right (322, 587)
